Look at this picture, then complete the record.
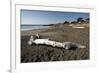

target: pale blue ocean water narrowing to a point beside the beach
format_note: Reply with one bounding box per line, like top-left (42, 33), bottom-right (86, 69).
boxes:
top-left (21, 25), bottom-right (50, 31)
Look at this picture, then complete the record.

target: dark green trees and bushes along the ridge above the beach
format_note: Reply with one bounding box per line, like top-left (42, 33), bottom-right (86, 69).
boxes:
top-left (63, 17), bottom-right (90, 24)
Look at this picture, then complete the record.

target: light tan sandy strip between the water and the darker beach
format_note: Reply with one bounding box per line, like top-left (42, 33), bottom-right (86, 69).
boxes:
top-left (20, 24), bottom-right (89, 36)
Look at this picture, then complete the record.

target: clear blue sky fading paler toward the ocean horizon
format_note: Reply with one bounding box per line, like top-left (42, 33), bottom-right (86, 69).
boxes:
top-left (21, 10), bottom-right (89, 25)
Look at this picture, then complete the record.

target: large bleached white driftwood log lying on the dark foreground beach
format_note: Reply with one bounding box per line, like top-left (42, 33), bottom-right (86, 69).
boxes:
top-left (28, 36), bottom-right (86, 49)
